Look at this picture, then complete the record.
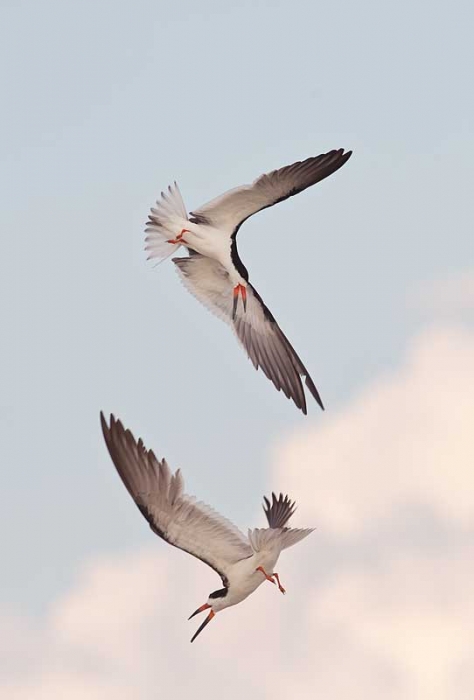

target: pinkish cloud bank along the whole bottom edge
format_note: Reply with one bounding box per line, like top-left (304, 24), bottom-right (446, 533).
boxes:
top-left (0, 546), bottom-right (474, 700)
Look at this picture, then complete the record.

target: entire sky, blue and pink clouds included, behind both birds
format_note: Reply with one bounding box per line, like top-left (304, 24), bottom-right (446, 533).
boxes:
top-left (0, 0), bottom-right (474, 700)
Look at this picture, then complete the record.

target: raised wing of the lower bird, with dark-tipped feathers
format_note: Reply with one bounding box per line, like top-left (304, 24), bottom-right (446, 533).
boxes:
top-left (101, 413), bottom-right (252, 587)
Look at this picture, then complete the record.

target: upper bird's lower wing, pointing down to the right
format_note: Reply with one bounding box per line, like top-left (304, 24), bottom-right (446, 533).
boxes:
top-left (173, 254), bottom-right (324, 414)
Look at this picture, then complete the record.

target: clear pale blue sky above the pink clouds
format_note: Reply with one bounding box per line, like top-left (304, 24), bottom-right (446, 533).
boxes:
top-left (0, 0), bottom-right (474, 610)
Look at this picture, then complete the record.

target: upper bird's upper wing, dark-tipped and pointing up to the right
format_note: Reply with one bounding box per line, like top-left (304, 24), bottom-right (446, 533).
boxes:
top-left (191, 148), bottom-right (352, 235)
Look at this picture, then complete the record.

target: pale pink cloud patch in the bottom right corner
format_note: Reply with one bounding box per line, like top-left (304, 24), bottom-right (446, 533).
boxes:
top-left (314, 547), bottom-right (474, 698)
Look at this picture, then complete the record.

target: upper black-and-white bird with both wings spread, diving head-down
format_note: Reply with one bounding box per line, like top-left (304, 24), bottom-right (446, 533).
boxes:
top-left (145, 148), bottom-right (352, 414)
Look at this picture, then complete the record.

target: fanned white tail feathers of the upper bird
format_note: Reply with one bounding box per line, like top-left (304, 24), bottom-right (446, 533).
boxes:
top-left (145, 182), bottom-right (188, 261)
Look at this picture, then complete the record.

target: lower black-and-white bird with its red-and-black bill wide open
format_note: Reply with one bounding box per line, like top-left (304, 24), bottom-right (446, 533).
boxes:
top-left (100, 413), bottom-right (313, 642)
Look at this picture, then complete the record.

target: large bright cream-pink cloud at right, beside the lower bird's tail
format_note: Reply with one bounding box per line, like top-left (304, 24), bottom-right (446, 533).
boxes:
top-left (275, 328), bottom-right (474, 536)
